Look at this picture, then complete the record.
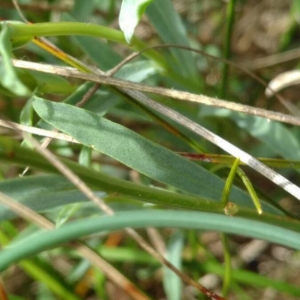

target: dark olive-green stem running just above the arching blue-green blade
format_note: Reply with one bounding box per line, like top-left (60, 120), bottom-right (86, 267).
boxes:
top-left (0, 138), bottom-right (300, 232)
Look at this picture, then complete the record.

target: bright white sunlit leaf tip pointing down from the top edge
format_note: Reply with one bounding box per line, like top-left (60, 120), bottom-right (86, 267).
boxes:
top-left (119, 0), bottom-right (153, 44)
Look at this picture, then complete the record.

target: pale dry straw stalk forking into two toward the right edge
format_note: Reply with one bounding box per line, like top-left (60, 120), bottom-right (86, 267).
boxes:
top-left (5, 60), bottom-right (300, 200)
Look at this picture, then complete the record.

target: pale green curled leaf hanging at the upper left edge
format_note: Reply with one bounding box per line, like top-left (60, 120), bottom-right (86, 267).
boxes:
top-left (0, 22), bottom-right (31, 96)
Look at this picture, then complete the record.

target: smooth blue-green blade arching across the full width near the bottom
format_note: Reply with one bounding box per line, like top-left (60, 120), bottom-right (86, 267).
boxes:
top-left (0, 211), bottom-right (300, 271)
